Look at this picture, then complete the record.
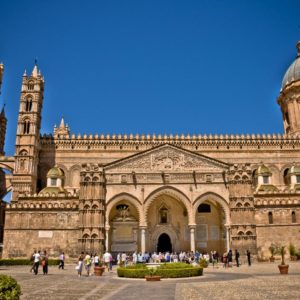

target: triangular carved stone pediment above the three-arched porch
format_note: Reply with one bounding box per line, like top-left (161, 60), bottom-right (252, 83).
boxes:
top-left (104, 144), bottom-right (229, 173)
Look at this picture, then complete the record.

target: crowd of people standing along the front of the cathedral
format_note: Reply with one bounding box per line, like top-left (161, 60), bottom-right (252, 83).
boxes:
top-left (30, 250), bottom-right (251, 277)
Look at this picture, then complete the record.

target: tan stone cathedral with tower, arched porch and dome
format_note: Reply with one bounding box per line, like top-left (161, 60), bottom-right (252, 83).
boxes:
top-left (1, 43), bottom-right (300, 257)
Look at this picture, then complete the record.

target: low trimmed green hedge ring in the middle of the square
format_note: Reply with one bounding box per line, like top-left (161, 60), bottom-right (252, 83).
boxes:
top-left (117, 263), bottom-right (203, 278)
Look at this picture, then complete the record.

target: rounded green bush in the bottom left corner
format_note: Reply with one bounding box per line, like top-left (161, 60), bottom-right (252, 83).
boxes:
top-left (0, 275), bottom-right (21, 300)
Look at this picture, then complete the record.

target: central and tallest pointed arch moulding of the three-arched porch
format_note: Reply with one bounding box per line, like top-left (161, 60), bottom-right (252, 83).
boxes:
top-left (144, 186), bottom-right (191, 224)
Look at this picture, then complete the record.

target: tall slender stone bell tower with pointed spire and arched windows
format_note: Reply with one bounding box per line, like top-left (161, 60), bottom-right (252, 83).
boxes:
top-left (12, 63), bottom-right (44, 200)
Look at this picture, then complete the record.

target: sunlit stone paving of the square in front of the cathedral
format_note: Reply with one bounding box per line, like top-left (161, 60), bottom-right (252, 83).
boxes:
top-left (0, 262), bottom-right (300, 300)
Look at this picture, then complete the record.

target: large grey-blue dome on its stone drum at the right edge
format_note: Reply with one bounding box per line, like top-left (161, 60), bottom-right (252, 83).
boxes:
top-left (277, 42), bottom-right (300, 134)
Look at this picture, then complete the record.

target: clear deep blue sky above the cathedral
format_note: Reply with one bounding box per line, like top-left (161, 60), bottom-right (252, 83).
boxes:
top-left (0, 0), bottom-right (300, 154)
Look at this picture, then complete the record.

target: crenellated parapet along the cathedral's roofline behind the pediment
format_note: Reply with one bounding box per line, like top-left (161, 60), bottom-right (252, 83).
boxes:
top-left (41, 134), bottom-right (300, 151)
